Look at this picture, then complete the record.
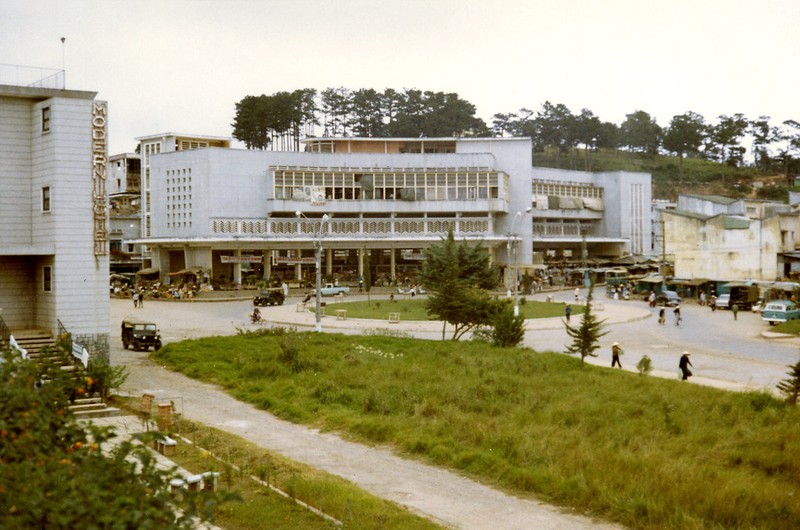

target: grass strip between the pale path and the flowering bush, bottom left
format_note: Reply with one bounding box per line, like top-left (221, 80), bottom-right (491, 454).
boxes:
top-left (147, 419), bottom-right (441, 530)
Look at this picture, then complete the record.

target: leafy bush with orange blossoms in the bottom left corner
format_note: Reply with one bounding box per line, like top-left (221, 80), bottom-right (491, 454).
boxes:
top-left (0, 352), bottom-right (228, 529)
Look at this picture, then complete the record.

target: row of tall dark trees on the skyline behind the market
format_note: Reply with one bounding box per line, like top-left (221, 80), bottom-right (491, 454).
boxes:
top-left (232, 87), bottom-right (800, 177)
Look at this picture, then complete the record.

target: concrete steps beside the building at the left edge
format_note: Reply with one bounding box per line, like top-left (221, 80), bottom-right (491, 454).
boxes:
top-left (12, 329), bottom-right (120, 418)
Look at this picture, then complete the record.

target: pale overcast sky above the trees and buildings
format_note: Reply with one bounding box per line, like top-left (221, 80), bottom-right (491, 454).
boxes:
top-left (0, 0), bottom-right (800, 155)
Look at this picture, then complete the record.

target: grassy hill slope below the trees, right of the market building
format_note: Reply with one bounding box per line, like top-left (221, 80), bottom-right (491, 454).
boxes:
top-left (533, 150), bottom-right (788, 200)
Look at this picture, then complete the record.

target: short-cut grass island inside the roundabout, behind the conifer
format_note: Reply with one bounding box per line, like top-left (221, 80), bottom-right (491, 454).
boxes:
top-left (320, 297), bottom-right (584, 320)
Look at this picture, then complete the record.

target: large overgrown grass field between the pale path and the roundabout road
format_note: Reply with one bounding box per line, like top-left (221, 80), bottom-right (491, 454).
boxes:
top-left (156, 333), bottom-right (800, 529)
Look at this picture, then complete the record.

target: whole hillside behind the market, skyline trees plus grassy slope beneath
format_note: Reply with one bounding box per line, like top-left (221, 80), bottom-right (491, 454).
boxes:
top-left (232, 87), bottom-right (800, 199)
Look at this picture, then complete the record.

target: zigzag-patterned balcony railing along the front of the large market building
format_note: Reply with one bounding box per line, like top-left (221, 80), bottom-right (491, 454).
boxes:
top-left (211, 217), bottom-right (490, 239)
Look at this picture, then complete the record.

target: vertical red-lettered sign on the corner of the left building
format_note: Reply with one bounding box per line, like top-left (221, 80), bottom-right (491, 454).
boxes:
top-left (92, 101), bottom-right (108, 256)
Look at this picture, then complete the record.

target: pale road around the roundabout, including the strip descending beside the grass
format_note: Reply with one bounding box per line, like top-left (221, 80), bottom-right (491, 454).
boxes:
top-left (111, 291), bottom-right (797, 529)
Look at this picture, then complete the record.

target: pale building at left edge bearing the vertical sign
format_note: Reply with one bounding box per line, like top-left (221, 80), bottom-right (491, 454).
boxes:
top-left (0, 67), bottom-right (109, 354)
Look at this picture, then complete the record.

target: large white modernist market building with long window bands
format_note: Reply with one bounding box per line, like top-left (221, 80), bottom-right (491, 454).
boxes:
top-left (139, 135), bottom-right (651, 284)
